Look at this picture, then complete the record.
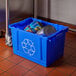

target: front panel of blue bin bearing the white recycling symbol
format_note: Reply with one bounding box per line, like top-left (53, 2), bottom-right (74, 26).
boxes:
top-left (18, 31), bottom-right (41, 59)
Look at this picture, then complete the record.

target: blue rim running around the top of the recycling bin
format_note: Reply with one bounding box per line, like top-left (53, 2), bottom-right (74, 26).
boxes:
top-left (9, 17), bottom-right (69, 38)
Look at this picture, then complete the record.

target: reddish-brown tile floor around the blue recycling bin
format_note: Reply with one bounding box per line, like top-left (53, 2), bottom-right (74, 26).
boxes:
top-left (0, 32), bottom-right (76, 76)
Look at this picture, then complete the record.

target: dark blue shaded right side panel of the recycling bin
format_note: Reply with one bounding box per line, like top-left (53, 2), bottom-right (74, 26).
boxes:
top-left (47, 32), bottom-right (65, 66)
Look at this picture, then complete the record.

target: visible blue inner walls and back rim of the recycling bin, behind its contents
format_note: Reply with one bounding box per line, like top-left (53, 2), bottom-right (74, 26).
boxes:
top-left (9, 18), bottom-right (67, 35)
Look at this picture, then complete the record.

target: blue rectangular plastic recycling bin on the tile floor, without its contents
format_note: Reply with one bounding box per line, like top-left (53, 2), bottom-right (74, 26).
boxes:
top-left (9, 18), bottom-right (68, 67)
